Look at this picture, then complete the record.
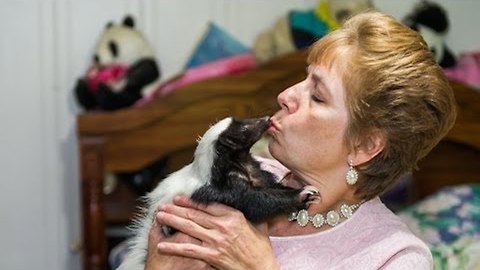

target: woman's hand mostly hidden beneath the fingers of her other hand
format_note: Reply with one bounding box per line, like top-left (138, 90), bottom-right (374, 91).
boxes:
top-left (145, 214), bottom-right (213, 270)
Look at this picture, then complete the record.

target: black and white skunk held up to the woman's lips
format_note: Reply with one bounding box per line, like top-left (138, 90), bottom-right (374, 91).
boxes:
top-left (118, 117), bottom-right (314, 270)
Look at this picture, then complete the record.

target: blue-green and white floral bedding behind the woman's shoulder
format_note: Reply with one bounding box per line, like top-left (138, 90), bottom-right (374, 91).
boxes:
top-left (398, 184), bottom-right (480, 270)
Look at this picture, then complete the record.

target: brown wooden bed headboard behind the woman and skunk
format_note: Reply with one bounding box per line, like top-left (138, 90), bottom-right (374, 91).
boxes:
top-left (77, 51), bottom-right (480, 270)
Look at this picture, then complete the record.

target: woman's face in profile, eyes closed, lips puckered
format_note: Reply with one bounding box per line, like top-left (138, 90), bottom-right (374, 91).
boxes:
top-left (269, 65), bottom-right (349, 187)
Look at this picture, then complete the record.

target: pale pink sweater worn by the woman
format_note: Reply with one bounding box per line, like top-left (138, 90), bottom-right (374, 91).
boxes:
top-left (259, 158), bottom-right (433, 270)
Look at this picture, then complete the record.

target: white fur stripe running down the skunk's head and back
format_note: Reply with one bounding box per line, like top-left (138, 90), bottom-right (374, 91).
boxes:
top-left (117, 118), bottom-right (232, 270)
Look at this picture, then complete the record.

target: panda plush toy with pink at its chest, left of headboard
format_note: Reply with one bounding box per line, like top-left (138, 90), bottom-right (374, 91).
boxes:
top-left (75, 16), bottom-right (160, 111)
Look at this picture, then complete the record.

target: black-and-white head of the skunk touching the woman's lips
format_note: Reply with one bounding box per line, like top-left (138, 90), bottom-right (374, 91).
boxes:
top-left (194, 117), bottom-right (270, 178)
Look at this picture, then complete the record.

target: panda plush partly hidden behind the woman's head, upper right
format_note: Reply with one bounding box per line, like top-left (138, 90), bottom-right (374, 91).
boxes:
top-left (404, 0), bottom-right (456, 68)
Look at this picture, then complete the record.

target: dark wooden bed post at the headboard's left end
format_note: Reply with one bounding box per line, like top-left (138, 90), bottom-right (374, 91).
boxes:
top-left (79, 137), bottom-right (106, 270)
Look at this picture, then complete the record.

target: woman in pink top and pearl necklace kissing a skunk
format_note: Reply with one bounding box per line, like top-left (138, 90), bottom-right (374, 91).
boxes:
top-left (147, 12), bottom-right (456, 269)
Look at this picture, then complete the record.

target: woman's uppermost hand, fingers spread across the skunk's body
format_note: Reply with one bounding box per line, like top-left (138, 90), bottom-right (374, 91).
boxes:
top-left (156, 196), bottom-right (279, 270)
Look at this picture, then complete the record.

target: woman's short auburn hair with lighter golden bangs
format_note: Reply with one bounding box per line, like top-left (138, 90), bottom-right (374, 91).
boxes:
top-left (308, 11), bottom-right (456, 199)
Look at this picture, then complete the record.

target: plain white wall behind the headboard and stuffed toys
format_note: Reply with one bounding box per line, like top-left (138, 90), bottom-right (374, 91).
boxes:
top-left (0, 0), bottom-right (480, 270)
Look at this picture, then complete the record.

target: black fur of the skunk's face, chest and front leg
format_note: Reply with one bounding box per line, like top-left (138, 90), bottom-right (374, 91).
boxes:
top-left (191, 118), bottom-right (305, 223)
